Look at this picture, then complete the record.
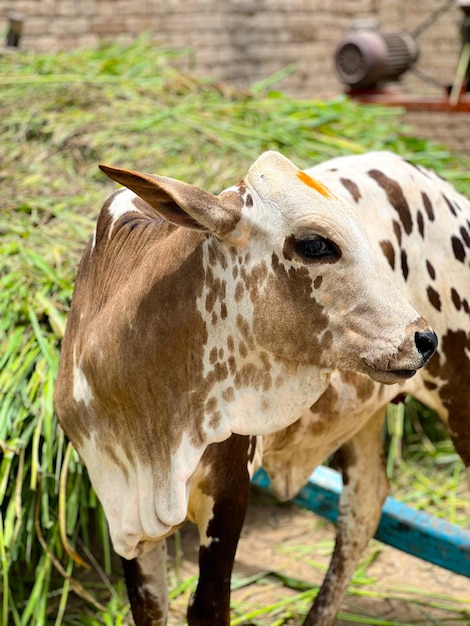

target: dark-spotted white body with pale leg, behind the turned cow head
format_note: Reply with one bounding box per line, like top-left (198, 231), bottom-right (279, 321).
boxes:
top-left (262, 152), bottom-right (470, 626)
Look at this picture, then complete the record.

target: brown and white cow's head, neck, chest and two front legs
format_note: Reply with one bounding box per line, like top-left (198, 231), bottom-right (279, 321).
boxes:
top-left (55, 152), bottom-right (436, 626)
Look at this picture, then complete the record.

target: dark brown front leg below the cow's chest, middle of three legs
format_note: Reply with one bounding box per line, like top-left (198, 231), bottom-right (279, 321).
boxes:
top-left (188, 435), bottom-right (255, 626)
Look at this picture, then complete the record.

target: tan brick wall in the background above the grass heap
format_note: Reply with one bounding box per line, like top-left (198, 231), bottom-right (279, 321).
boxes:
top-left (0, 0), bottom-right (470, 154)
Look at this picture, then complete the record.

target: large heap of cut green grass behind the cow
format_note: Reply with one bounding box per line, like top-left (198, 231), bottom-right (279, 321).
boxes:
top-left (0, 38), bottom-right (470, 626)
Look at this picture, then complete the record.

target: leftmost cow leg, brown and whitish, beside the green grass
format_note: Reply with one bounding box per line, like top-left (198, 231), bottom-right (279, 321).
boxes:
top-left (122, 539), bottom-right (168, 626)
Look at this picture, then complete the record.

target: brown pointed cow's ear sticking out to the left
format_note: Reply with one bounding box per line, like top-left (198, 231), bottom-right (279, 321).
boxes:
top-left (99, 165), bottom-right (241, 237)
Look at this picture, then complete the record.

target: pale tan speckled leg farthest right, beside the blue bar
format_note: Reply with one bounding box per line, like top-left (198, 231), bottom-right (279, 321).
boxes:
top-left (304, 409), bottom-right (388, 626)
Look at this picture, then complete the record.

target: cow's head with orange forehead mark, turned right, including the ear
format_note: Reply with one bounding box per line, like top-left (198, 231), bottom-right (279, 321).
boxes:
top-left (101, 151), bottom-right (437, 390)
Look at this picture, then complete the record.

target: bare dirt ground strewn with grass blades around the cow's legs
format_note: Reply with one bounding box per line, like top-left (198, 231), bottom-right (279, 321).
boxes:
top-left (165, 491), bottom-right (470, 626)
